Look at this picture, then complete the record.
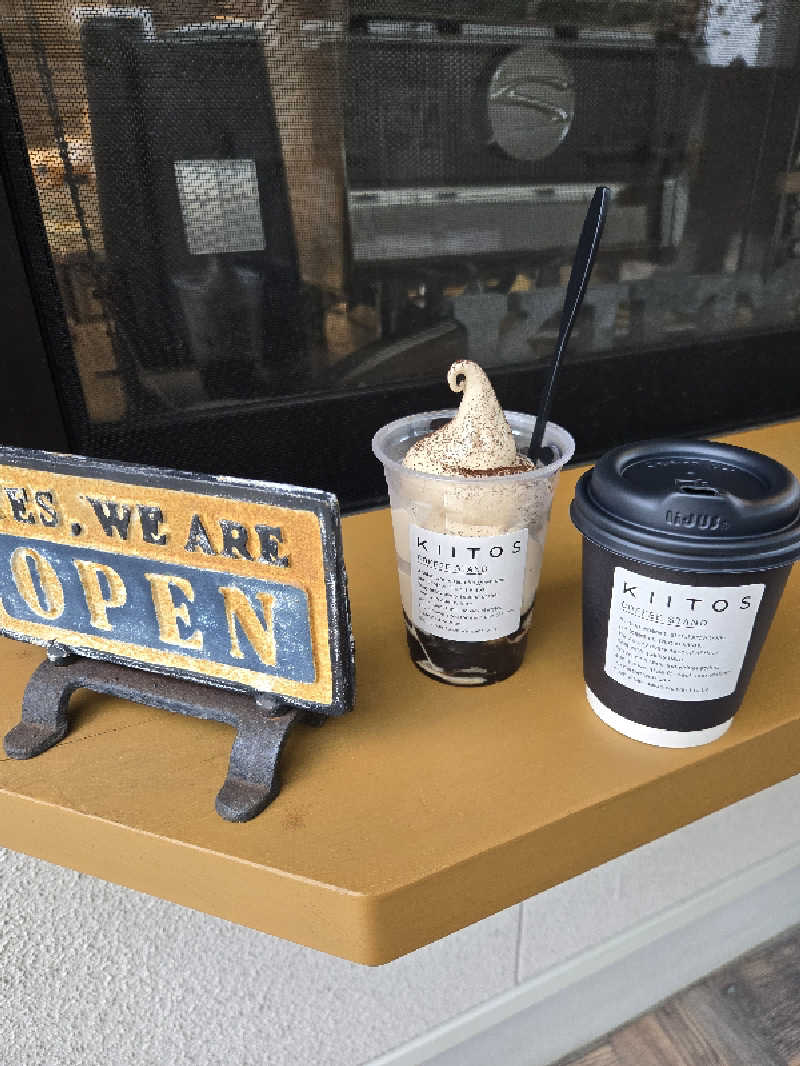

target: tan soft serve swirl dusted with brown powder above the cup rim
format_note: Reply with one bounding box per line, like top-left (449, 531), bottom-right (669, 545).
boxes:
top-left (403, 359), bottom-right (534, 478)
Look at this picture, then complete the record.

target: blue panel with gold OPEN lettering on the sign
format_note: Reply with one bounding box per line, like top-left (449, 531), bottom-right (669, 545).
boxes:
top-left (0, 536), bottom-right (315, 682)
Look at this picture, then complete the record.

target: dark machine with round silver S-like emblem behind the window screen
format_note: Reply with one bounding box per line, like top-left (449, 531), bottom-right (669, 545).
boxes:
top-left (346, 20), bottom-right (697, 264)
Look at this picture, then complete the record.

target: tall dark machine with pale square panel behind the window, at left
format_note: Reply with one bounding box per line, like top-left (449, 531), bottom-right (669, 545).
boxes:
top-left (81, 15), bottom-right (303, 401)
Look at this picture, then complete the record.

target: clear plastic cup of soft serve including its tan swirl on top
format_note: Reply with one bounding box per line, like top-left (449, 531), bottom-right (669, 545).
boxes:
top-left (373, 360), bottom-right (573, 684)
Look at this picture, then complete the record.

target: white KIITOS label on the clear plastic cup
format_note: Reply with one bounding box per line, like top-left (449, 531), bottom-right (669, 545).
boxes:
top-left (409, 523), bottom-right (528, 641)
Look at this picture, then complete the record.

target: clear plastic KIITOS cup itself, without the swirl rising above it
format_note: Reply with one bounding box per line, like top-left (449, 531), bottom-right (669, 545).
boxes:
top-left (372, 410), bottom-right (575, 685)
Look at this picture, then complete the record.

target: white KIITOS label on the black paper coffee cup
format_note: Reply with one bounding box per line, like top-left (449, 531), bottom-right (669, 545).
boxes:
top-left (605, 566), bottom-right (764, 700)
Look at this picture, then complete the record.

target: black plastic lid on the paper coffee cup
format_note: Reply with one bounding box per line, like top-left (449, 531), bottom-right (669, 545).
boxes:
top-left (570, 440), bottom-right (800, 574)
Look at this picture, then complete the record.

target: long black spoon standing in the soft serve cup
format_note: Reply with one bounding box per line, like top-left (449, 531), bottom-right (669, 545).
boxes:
top-left (528, 185), bottom-right (611, 464)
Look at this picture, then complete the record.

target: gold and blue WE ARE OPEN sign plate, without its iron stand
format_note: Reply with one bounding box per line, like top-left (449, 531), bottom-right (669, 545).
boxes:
top-left (0, 448), bottom-right (353, 714)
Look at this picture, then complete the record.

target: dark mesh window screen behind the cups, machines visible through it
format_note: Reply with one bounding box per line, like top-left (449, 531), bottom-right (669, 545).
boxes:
top-left (0, 0), bottom-right (800, 445)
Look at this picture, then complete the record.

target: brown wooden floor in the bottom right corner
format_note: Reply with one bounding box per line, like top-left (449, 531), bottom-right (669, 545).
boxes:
top-left (555, 925), bottom-right (800, 1066)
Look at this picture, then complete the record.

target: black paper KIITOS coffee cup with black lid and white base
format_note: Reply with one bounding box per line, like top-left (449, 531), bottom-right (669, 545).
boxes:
top-left (570, 440), bottom-right (800, 747)
